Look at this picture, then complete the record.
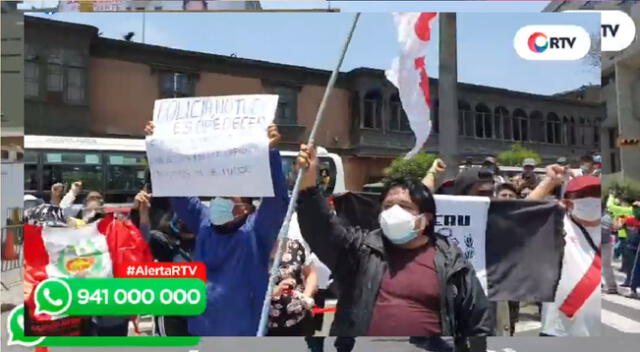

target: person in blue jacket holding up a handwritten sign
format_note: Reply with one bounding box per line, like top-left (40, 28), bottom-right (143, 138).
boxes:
top-left (145, 123), bottom-right (289, 336)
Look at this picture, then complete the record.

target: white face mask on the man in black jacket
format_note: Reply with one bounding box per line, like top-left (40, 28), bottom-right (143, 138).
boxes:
top-left (379, 205), bottom-right (420, 245)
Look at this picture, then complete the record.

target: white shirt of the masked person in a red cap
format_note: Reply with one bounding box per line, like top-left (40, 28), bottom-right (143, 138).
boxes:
top-left (542, 215), bottom-right (602, 336)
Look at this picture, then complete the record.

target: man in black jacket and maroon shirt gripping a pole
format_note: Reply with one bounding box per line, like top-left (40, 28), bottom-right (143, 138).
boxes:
top-left (298, 145), bottom-right (494, 337)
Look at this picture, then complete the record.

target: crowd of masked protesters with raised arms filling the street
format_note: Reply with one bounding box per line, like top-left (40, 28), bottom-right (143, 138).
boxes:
top-left (20, 119), bottom-right (640, 352)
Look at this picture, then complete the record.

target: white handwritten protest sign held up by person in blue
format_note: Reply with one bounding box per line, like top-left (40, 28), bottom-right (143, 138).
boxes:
top-left (146, 95), bottom-right (278, 197)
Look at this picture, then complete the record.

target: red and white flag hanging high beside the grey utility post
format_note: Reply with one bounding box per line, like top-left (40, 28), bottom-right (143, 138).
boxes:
top-left (386, 12), bottom-right (437, 158)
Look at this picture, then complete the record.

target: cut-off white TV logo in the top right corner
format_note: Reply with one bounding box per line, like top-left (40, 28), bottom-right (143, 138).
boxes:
top-left (566, 10), bottom-right (636, 51)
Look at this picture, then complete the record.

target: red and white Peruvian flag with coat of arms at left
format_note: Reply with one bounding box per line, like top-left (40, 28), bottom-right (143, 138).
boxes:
top-left (24, 215), bottom-right (153, 336)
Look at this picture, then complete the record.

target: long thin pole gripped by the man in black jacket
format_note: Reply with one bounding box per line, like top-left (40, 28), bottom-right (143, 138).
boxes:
top-left (258, 12), bottom-right (360, 336)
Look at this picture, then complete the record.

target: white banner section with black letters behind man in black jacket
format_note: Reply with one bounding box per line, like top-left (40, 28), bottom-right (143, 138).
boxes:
top-left (435, 195), bottom-right (491, 294)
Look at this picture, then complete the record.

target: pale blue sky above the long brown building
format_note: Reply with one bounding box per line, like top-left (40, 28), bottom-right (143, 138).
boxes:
top-left (27, 2), bottom-right (600, 94)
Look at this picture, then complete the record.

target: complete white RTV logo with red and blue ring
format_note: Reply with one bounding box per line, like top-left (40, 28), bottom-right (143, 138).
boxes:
top-left (513, 25), bottom-right (591, 60)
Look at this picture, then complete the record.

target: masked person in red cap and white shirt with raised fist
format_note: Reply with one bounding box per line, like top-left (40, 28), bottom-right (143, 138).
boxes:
top-left (529, 169), bottom-right (602, 336)
